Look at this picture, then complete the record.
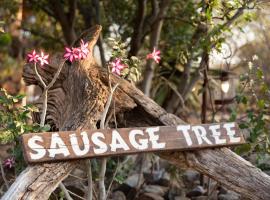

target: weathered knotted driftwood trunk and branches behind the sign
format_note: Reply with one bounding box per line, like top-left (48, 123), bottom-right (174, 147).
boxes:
top-left (2, 26), bottom-right (270, 200)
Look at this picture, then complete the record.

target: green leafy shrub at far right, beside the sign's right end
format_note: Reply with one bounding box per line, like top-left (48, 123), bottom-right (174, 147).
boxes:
top-left (231, 62), bottom-right (270, 167)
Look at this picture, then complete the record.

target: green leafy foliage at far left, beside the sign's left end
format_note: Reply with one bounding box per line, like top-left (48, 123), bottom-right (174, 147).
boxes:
top-left (0, 89), bottom-right (50, 171)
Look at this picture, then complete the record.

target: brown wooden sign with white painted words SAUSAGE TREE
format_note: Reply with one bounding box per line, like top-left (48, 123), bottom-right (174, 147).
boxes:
top-left (22, 122), bottom-right (245, 163)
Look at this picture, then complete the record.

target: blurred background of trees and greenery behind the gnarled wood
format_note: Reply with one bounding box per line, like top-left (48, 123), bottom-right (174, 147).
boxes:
top-left (0, 0), bottom-right (270, 199)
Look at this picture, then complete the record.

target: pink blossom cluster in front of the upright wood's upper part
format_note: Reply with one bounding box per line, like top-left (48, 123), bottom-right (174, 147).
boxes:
top-left (64, 40), bottom-right (89, 62)
